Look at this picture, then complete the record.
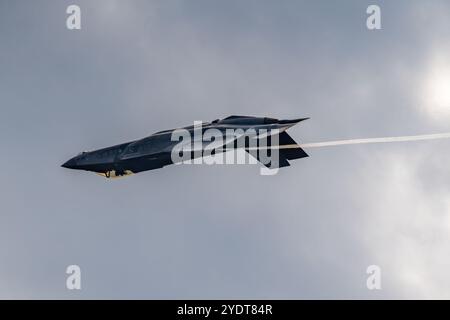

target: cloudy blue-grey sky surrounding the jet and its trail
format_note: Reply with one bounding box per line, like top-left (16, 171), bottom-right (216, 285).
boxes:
top-left (0, 0), bottom-right (450, 299)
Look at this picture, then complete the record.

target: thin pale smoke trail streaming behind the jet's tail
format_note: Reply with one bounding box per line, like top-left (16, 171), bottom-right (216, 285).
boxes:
top-left (300, 132), bottom-right (450, 148)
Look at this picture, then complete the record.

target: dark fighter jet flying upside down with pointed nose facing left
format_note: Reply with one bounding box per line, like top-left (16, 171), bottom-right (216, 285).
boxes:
top-left (62, 116), bottom-right (308, 178)
